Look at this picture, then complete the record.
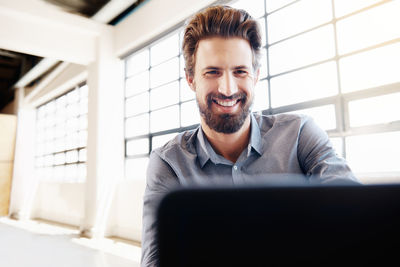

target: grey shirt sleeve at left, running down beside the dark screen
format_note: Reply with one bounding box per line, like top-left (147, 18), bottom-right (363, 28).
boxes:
top-left (141, 152), bottom-right (178, 267)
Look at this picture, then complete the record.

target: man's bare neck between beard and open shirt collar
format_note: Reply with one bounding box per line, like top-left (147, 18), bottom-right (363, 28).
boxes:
top-left (201, 116), bottom-right (250, 162)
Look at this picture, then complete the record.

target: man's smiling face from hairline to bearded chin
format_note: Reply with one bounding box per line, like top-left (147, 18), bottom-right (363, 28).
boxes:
top-left (186, 37), bottom-right (258, 133)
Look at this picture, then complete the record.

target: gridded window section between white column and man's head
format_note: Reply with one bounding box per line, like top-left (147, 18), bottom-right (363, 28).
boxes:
top-left (125, 28), bottom-right (199, 179)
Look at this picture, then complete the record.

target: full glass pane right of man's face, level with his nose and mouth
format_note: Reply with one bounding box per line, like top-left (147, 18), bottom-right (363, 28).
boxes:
top-left (271, 61), bottom-right (338, 107)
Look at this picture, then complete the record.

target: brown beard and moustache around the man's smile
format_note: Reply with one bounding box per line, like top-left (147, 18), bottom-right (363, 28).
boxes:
top-left (196, 93), bottom-right (253, 134)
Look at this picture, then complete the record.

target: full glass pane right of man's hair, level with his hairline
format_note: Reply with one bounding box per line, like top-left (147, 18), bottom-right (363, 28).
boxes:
top-left (268, 0), bottom-right (332, 44)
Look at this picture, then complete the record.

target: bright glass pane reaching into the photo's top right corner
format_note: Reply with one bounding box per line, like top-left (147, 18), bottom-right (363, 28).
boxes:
top-left (337, 1), bottom-right (400, 54)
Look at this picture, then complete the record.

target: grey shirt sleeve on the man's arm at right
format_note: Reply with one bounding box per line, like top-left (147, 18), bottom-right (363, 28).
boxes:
top-left (298, 117), bottom-right (360, 184)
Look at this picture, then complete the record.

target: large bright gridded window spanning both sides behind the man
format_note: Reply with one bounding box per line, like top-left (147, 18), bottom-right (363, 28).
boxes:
top-left (125, 0), bottom-right (400, 182)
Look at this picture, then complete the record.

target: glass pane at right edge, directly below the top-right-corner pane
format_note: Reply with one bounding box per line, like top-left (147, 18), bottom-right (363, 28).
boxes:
top-left (339, 43), bottom-right (400, 92)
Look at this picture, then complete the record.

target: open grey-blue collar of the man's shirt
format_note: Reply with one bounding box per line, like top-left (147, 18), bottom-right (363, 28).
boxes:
top-left (196, 113), bottom-right (263, 168)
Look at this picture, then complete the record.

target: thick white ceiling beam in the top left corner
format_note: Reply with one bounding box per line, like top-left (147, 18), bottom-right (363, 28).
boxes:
top-left (0, 0), bottom-right (107, 65)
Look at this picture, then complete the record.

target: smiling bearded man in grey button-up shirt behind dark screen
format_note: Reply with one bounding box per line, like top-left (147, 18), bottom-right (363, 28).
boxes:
top-left (142, 6), bottom-right (357, 266)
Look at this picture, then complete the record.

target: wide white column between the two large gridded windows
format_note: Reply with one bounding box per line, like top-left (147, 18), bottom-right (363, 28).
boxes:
top-left (81, 27), bottom-right (124, 237)
